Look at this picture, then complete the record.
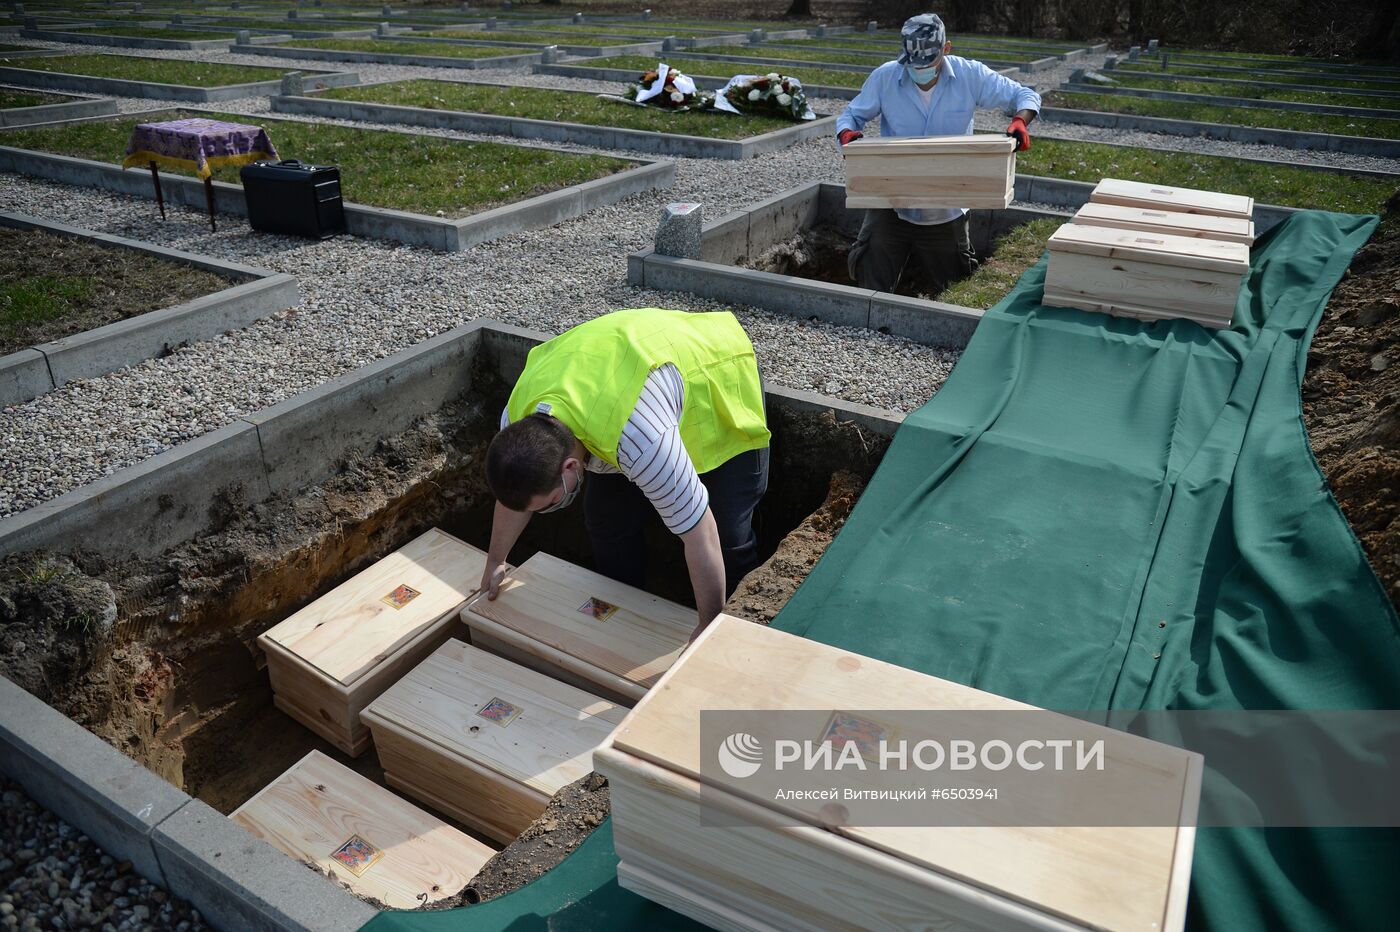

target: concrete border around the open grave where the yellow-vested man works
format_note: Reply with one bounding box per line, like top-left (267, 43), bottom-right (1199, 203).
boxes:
top-left (0, 320), bottom-right (904, 932)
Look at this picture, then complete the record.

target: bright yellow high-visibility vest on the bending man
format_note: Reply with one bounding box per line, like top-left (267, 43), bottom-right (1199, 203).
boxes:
top-left (505, 308), bottom-right (770, 473)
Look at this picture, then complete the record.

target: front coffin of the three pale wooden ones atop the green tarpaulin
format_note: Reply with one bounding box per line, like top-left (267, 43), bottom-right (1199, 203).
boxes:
top-left (1044, 224), bottom-right (1249, 327)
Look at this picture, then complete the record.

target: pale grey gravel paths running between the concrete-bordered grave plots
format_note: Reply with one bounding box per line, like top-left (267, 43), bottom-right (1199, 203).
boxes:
top-left (0, 43), bottom-right (1376, 516)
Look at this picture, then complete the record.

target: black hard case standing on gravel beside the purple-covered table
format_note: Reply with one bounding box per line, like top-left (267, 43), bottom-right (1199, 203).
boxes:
top-left (238, 158), bottom-right (346, 239)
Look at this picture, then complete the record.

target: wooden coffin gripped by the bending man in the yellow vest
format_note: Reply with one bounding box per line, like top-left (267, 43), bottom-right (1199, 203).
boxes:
top-left (462, 553), bottom-right (696, 705)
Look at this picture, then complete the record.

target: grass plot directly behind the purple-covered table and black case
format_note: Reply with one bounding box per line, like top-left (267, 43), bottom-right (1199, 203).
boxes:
top-left (0, 112), bottom-right (636, 217)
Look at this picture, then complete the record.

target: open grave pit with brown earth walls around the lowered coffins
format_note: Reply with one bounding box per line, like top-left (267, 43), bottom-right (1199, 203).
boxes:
top-left (0, 325), bottom-right (899, 905)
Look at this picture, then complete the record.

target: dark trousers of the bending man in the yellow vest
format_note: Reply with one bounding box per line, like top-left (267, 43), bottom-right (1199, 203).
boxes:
top-left (584, 446), bottom-right (769, 598)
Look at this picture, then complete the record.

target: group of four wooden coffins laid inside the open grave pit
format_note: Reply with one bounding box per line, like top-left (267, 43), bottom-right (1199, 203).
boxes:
top-left (243, 529), bottom-right (694, 884)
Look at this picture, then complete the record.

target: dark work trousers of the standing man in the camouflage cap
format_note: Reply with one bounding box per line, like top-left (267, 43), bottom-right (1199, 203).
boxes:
top-left (847, 210), bottom-right (977, 297)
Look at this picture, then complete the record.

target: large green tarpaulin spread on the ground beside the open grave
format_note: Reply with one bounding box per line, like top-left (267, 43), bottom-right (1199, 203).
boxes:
top-left (371, 211), bottom-right (1400, 931)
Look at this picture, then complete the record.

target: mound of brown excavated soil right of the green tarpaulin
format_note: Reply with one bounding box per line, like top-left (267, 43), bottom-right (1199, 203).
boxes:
top-left (1302, 216), bottom-right (1400, 609)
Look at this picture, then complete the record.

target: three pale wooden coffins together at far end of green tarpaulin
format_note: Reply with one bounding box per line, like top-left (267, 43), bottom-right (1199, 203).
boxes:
top-left (1044, 178), bottom-right (1254, 329)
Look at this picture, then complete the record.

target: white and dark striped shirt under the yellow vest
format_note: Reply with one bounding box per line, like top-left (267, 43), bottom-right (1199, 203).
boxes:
top-left (501, 362), bottom-right (710, 535)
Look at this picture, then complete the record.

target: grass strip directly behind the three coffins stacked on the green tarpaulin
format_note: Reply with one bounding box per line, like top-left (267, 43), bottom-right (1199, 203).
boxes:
top-left (1016, 137), bottom-right (1396, 214)
